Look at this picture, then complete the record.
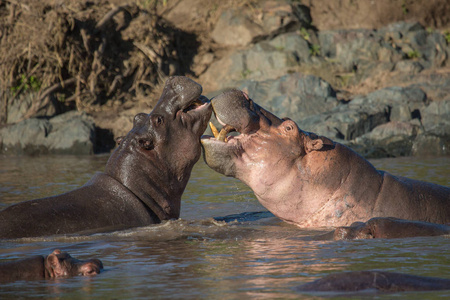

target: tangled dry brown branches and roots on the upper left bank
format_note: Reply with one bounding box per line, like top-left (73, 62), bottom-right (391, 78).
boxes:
top-left (0, 0), bottom-right (200, 124)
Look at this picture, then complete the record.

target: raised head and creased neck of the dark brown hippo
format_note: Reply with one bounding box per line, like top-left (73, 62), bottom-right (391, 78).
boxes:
top-left (106, 76), bottom-right (212, 220)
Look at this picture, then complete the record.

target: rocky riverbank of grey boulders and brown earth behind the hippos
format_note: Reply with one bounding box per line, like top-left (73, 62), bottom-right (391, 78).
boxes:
top-left (0, 0), bottom-right (450, 157)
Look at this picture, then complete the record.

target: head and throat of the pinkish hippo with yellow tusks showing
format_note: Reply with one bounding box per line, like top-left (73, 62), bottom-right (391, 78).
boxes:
top-left (201, 90), bottom-right (333, 215)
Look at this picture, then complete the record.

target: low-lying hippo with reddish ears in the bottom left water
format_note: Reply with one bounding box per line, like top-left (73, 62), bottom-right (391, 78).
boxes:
top-left (0, 249), bottom-right (103, 282)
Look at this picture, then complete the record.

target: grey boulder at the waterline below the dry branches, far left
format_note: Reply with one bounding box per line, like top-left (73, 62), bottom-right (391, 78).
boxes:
top-left (0, 111), bottom-right (95, 155)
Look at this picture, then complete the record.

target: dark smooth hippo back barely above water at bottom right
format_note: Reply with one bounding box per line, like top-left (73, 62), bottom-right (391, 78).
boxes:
top-left (296, 271), bottom-right (450, 293)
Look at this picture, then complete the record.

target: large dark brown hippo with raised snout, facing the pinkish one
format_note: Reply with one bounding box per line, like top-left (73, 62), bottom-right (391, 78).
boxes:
top-left (0, 76), bottom-right (212, 239)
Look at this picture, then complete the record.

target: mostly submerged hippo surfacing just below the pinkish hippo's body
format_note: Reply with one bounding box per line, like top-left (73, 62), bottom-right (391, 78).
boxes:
top-left (331, 218), bottom-right (450, 240)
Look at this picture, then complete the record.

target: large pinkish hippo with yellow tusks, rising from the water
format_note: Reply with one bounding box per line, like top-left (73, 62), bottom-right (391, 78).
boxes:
top-left (202, 90), bottom-right (450, 227)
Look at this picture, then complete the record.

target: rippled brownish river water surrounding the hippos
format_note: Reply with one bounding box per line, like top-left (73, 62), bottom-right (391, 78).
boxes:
top-left (0, 156), bottom-right (450, 299)
